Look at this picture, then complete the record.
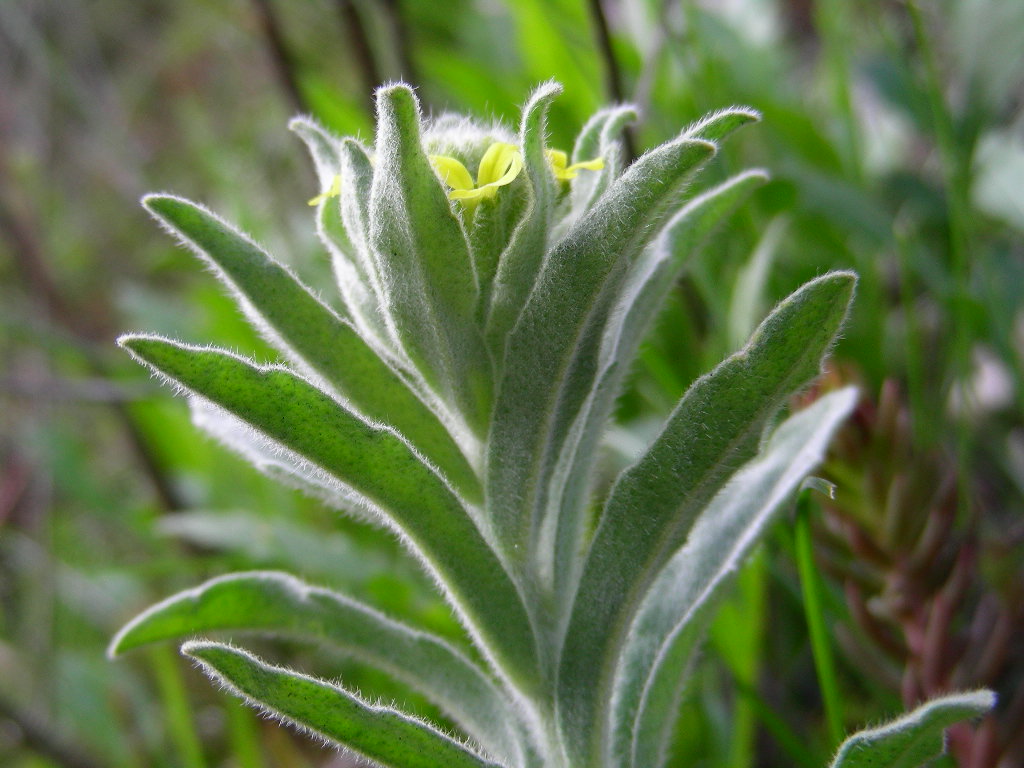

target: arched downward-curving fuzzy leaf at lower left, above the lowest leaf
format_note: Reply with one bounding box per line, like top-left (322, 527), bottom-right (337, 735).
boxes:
top-left (108, 571), bottom-right (520, 760)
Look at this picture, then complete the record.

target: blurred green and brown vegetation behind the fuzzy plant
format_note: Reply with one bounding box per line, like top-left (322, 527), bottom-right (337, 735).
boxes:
top-left (0, 0), bottom-right (1024, 768)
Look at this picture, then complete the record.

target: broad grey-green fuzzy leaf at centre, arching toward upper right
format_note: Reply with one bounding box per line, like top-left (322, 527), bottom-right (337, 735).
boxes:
top-left (486, 138), bottom-right (715, 559)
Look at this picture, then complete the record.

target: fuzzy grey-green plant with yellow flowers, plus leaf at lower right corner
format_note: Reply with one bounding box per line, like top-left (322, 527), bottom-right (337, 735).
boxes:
top-left (111, 84), bottom-right (990, 768)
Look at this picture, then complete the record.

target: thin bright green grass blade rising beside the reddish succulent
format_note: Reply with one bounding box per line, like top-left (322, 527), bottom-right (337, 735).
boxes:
top-left (796, 489), bottom-right (845, 749)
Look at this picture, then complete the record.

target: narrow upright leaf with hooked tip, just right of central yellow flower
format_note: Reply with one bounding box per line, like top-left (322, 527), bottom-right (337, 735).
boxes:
top-left (486, 82), bottom-right (562, 356)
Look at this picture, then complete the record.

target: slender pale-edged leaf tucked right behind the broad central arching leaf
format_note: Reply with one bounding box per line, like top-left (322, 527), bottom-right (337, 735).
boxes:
top-left (541, 171), bottom-right (766, 599)
